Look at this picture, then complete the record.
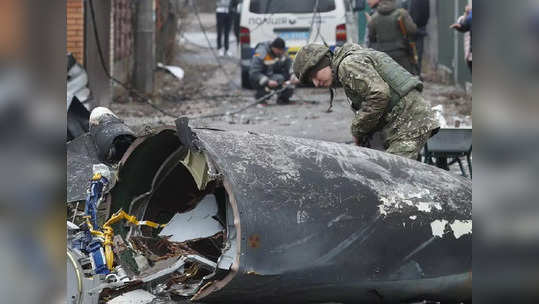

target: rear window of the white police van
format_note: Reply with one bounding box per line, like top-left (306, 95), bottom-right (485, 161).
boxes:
top-left (249, 0), bottom-right (335, 14)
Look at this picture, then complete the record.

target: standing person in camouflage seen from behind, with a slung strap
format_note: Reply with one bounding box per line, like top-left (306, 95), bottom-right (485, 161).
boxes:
top-left (368, 0), bottom-right (419, 75)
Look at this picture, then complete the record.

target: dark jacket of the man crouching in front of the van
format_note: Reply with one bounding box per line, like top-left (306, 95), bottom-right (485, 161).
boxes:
top-left (249, 41), bottom-right (292, 87)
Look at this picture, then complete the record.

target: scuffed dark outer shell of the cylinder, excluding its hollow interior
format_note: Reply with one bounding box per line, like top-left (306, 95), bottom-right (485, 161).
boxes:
top-left (172, 124), bottom-right (472, 303)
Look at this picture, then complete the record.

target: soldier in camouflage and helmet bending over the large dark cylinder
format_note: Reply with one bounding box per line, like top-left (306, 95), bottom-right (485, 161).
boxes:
top-left (293, 43), bottom-right (439, 159)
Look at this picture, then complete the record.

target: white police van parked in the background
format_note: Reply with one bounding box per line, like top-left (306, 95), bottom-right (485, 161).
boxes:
top-left (239, 0), bottom-right (364, 88)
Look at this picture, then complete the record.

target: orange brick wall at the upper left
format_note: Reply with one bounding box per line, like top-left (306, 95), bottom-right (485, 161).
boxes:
top-left (66, 0), bottom-right (84, 64)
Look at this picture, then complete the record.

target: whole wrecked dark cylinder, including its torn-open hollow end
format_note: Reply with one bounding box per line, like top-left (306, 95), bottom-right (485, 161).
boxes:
top-left (88, 119), bottom-right (472, 303)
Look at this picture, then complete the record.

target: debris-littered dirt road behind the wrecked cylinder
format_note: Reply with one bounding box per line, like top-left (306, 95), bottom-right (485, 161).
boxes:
top-left (111, 14), bottom-right (472, 142)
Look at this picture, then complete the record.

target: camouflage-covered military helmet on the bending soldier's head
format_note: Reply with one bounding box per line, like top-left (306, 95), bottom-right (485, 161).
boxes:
top-left (293, 43), bottom-right (331, 83)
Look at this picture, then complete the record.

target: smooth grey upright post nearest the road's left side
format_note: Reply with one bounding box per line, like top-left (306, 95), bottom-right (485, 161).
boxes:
top-left (133, 0), bottom-right (155, 94)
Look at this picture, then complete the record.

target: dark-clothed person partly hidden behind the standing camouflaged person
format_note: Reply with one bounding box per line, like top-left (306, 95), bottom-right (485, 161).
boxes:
top-left (402, 0), bottom-right (430, 77)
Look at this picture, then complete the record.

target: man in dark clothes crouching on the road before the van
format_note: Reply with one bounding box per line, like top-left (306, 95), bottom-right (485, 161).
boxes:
top-left (249, 38), bottom-right (295, 104)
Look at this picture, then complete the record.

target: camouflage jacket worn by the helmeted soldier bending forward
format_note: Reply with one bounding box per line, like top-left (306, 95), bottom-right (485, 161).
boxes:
top-left (331, 44), bottom-right (439, 141)
